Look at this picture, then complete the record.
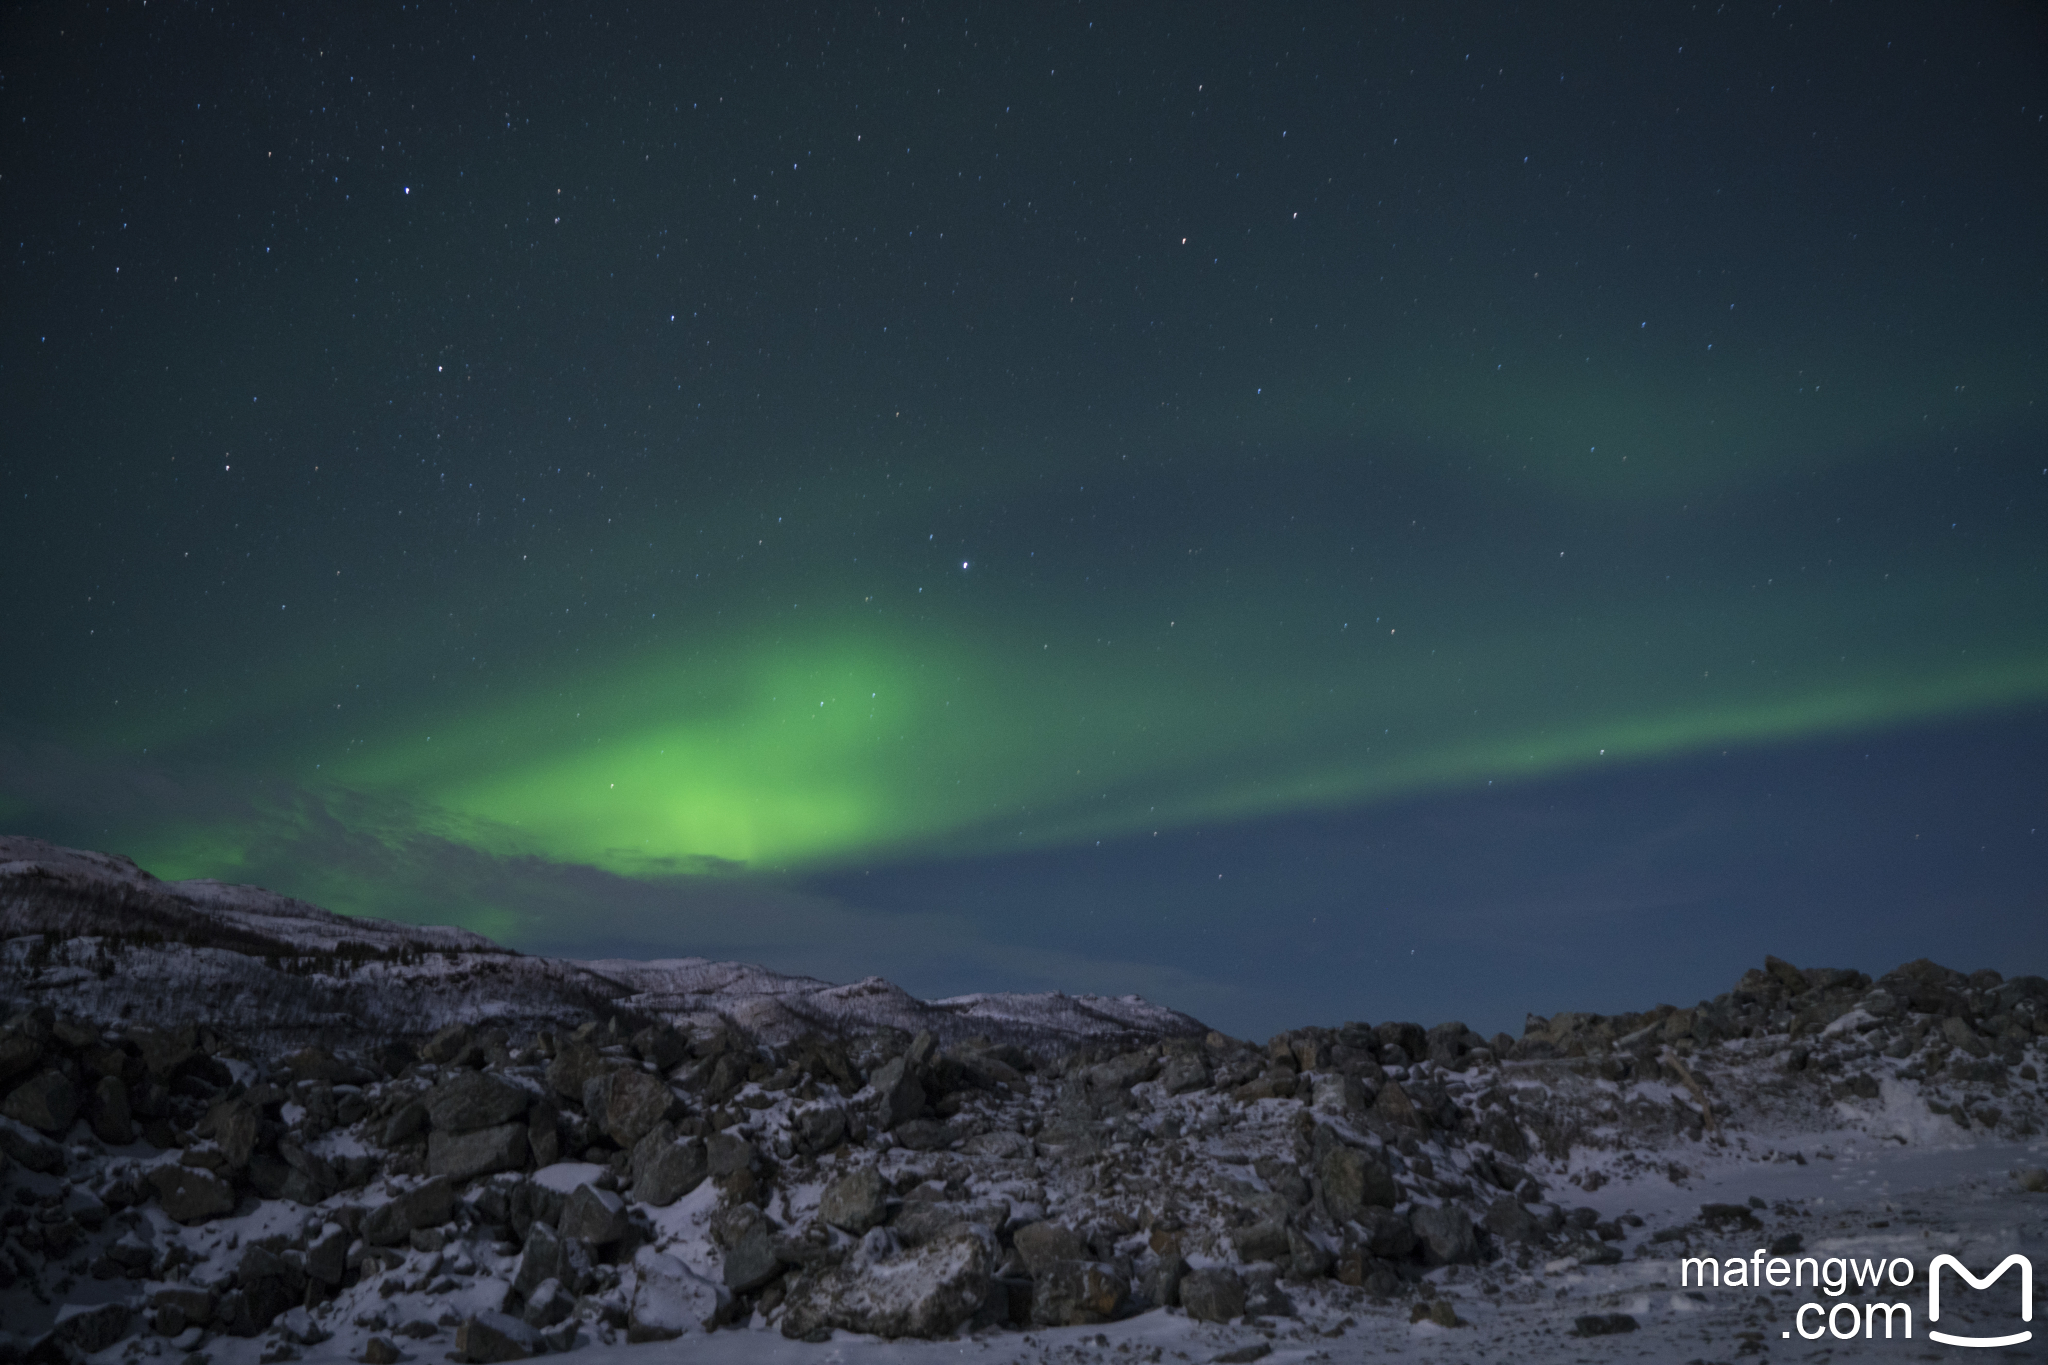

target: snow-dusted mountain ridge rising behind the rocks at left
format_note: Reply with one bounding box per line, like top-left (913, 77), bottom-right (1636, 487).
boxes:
top-left (0, 837), bottom-right (1206, 1054)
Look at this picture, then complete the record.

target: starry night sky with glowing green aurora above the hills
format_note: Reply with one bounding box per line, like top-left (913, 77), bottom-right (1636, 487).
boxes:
top-left (0, 0), bottom-right (2048, 1038)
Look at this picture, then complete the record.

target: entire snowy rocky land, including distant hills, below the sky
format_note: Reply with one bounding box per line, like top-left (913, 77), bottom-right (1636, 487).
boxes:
top-left (0, 839), bottom-right (2048, 1365)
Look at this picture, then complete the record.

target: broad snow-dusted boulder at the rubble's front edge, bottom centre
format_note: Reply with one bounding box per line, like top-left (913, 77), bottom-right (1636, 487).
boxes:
top-left (782, 1234), bottom-right (991, 1338)
